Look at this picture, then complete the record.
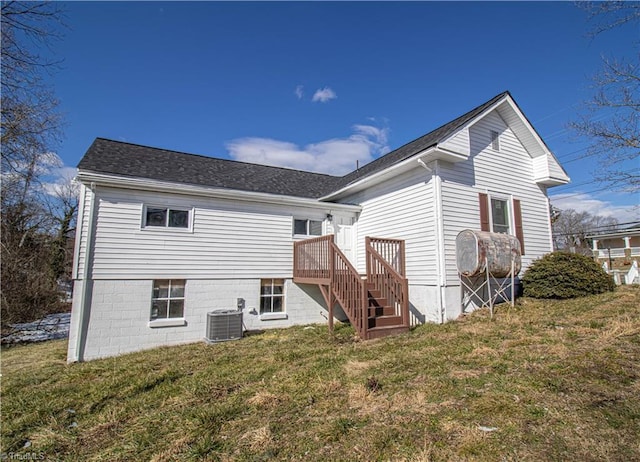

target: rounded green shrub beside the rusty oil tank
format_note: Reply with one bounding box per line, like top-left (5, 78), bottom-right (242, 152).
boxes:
top-left (522, 252), bottom-right (615, 299)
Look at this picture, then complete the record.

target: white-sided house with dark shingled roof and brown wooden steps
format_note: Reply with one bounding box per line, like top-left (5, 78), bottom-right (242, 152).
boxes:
top-left (68, 92), bottom-right (569, 361)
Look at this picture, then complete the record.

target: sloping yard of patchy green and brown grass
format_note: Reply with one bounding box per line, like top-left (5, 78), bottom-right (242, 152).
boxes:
top-left (2, 286), bottom-right (640, 461)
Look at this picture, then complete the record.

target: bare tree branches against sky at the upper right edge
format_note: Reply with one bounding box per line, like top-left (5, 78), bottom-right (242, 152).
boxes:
top-left (570, 1), bottom-right (640, 192)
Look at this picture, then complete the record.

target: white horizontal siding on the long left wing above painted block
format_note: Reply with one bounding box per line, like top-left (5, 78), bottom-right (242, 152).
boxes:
top-left (80, 188), bottom-right (350, 279)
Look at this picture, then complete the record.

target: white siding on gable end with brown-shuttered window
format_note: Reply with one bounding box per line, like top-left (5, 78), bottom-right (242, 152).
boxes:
top-left (441, 112), bottom-right (551, 282)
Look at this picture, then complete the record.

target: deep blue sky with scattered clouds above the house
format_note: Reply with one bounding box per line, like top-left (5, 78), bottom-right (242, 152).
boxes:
top-left (47, 2), bottom-right (640, 221)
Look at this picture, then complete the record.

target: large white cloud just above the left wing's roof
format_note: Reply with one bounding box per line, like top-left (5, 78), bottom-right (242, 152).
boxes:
top-left (226, 125), bottom-right (389, 175)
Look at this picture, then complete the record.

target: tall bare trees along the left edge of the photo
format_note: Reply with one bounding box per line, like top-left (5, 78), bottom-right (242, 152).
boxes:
top-left (0, 1), bottom-right (68, 327)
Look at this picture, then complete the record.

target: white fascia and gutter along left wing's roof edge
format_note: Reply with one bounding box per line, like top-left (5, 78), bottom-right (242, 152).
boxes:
top-left (76, 170), bottom-right (362, 213)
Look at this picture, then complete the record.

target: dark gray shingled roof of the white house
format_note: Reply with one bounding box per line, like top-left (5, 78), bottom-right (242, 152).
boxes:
top-left (78, 92), bottom-right (509, 198)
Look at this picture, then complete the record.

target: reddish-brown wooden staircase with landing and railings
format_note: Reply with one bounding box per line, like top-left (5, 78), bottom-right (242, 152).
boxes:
top-left (293, 235), bottom-right (409, 340)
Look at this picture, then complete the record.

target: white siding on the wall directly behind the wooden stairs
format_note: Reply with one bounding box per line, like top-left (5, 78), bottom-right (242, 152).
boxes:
top-left (338, 168), bottom-right (436, 284)
